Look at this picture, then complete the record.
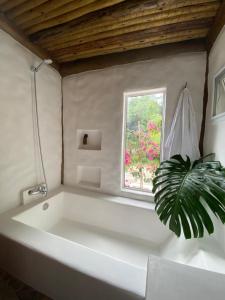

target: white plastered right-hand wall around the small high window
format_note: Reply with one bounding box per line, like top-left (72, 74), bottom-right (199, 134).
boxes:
top-left (204, 27), bottom-right (225, 251)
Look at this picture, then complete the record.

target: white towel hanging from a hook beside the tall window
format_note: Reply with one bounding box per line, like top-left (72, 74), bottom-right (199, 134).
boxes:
top-left (163, 87), bottom-right (200, 161)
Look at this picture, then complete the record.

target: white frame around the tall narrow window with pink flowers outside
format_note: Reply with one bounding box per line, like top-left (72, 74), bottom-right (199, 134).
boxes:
top-left (120, 87), bottom-right (167, 196)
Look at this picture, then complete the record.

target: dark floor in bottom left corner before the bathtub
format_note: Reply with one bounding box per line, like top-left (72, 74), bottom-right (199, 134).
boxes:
top-left (0, 270), bottom-right (51, 300)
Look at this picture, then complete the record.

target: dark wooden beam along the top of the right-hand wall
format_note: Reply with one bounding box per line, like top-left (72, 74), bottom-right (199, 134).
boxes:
top-left (207, 0), bottom-right (225, 51)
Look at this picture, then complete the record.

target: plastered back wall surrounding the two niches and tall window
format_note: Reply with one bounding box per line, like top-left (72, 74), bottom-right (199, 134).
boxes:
top-left (63, 52), bottom-right (206, 198)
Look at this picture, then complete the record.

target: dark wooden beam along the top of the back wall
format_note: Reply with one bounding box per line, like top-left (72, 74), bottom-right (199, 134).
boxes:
top-left (60, 39), bottom-right (206, 76)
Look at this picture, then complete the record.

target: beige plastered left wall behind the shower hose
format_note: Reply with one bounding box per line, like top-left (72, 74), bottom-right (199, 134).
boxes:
top-left (0, 30), bottom-right (62, 212)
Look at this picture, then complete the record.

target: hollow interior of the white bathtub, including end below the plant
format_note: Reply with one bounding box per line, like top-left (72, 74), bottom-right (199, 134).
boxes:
top-left (13, 192), bottom-right (225, 273)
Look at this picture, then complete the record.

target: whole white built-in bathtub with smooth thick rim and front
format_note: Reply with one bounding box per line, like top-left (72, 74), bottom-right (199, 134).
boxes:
top-left (0, 187), bottom-right (225, 300)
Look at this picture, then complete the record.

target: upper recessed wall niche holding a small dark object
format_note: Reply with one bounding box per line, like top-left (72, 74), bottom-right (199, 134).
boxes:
top-left (77, 129), bottom-right (102, 150)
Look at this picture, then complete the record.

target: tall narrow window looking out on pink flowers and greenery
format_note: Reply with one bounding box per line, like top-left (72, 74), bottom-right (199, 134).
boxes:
top-left (122, 89), bottom-right (166, 193)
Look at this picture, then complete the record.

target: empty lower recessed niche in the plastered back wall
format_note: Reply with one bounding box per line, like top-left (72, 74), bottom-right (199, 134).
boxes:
top-left (77, 166), bottom-right (101, 188)
